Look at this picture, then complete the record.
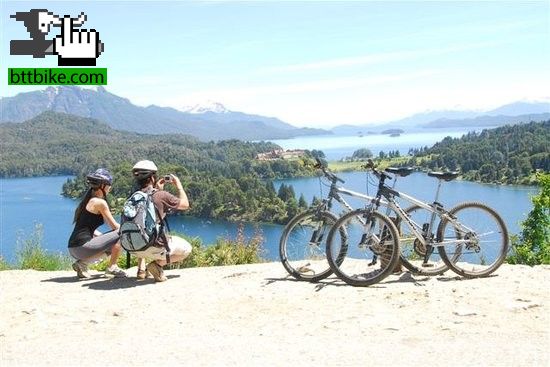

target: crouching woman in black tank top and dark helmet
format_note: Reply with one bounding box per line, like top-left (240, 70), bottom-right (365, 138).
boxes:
top-left (69, 168), bottom-right (126, 278)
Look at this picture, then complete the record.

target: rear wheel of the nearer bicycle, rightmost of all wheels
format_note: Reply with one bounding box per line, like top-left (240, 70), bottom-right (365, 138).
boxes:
top-left (437, 202), bottom-right (508, 278)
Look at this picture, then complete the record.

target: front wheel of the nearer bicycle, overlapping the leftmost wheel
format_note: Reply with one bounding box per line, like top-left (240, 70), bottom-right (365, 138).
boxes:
top-left (327, 209), bottom-right (399, 287)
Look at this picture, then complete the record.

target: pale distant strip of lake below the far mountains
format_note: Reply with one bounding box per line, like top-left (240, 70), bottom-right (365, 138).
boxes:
top-left (270, 128), bottom-right (483, 160)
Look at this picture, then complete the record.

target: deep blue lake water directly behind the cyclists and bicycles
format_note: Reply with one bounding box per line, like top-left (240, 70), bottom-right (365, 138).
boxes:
top-left (0, 172), bottom-right (538, 262)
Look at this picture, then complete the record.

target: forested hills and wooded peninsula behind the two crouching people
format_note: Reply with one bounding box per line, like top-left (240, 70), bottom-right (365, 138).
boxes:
top-left (0, 112), bottom-right (320, 223)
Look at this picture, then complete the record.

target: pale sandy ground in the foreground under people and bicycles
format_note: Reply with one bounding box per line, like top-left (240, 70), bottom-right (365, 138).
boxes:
top-left (0, 263), bottom-right (550, 366)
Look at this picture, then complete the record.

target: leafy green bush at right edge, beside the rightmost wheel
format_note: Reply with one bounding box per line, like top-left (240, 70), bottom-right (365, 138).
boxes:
top-left (507, 173), bottom-right (550, 265)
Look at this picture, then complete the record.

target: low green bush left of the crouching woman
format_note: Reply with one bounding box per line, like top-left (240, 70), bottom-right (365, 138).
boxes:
top-left (15, 224), bottom-right (72, 271)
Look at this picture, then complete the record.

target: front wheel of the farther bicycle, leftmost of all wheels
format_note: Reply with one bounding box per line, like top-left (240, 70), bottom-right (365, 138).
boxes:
top-left (279, 209), bottom-right (344, 282)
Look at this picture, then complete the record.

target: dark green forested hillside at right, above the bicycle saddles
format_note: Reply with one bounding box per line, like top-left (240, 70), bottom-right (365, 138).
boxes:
top-left (408, 121), bottom-right (550, 185)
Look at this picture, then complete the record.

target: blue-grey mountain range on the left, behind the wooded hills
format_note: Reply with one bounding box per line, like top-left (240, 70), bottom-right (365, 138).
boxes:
top-left (0, 86), bottom-right (330, 141)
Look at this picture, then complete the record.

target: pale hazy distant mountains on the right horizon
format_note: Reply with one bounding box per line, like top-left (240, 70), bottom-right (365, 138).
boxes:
top-left (331, 101), bottom-right (550, 135)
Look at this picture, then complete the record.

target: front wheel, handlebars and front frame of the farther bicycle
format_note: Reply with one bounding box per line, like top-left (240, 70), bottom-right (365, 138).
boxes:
top-left (279, 160), bottom-right (412, 282)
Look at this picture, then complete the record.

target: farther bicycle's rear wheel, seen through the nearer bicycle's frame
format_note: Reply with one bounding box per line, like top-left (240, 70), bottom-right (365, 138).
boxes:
top-left (397, 205), bottom-right (449, 275)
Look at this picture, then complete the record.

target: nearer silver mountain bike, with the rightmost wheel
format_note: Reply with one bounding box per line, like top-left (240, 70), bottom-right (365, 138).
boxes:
top-left (327, 161), bottom-right (508, 285)
